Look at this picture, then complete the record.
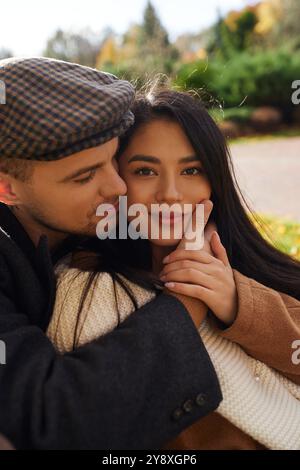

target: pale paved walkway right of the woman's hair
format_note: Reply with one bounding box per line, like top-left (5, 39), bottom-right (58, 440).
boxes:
top-left (231, 137), bottom-right (300, 222)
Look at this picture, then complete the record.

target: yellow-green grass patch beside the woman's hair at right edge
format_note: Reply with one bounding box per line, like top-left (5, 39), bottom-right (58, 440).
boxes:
top-left (252, 214), bottom-right (300, 261)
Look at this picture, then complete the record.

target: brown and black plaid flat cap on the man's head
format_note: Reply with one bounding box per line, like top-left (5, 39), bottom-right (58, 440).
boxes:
top-left (0, 57), bottom-right (134, 161)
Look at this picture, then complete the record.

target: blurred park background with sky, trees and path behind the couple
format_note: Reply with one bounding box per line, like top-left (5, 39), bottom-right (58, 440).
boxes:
top-left (0, 0), bottom-right (300, 259)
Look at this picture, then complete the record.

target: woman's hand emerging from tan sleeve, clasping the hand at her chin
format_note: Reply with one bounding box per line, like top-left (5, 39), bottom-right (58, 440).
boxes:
top-left (160, 232), bottom-right (238, 326)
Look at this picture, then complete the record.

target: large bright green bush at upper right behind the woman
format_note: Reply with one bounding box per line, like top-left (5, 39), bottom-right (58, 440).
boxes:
top-left (174, 50), bottom-right (300, 109)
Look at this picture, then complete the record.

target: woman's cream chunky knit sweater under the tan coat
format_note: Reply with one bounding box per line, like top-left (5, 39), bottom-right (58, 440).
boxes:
top-left (47, 265), bottom-right (300, 450)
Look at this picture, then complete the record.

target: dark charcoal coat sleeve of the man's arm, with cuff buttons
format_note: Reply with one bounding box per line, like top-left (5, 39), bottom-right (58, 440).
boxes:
top-left (0, 284), bottom-right (221, 449)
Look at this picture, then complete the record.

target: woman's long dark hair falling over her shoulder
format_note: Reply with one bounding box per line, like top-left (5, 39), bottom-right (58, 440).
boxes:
top-left (67, 89), bottom-right (300, 348)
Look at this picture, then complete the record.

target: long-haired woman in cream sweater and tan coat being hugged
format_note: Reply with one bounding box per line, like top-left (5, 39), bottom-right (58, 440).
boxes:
top-left (48, 90), bottom-right (300, 449)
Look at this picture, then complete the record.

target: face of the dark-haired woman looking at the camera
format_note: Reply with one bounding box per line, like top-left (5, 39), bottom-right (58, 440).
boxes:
top-left (119, 119), bottom-right (211, 246)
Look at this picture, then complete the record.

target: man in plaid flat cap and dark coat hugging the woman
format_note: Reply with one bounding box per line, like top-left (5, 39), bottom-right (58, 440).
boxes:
top-left (0, 58), bottom-right (221, 449)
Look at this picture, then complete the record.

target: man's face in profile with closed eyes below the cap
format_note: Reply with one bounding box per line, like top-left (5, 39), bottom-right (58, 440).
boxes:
top-left (7, 138), bottom-right (127, 242)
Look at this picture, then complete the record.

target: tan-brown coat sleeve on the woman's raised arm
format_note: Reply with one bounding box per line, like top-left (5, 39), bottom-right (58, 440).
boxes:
top-left (211, 270), bottom-right (300, 384)
